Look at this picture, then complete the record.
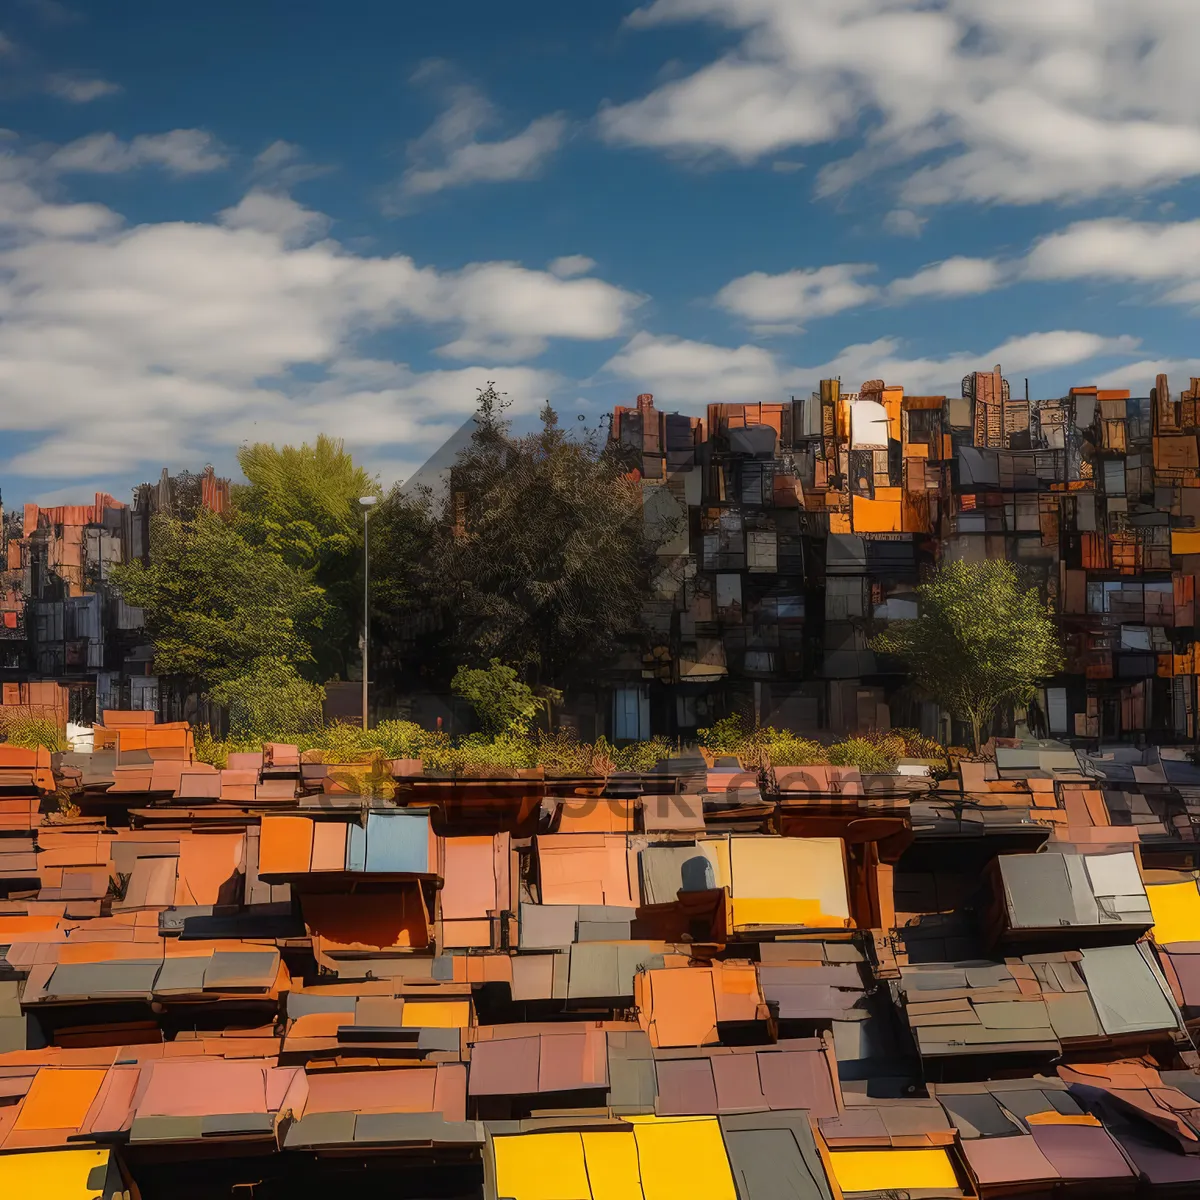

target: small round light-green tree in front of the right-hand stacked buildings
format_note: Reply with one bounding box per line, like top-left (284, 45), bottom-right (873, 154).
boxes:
top-left (871, 559), bottom-right (1062, 750)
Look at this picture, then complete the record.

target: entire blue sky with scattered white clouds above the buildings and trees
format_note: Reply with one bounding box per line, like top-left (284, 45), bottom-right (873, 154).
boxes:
top-left (0, 0), bottom-right (1200, 506)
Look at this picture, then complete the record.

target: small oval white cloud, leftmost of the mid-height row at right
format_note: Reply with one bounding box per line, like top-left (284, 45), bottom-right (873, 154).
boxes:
top-left (716, 263), bottom-right (878, 331)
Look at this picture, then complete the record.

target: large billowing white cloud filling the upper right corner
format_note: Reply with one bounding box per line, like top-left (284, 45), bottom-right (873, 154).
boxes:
top-left (599, 0), bottom-right (1200, 206)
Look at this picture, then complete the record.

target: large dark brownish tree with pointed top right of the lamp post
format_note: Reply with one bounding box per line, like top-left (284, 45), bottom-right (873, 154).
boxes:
top-left (372, 385), bottom-right (655, 689)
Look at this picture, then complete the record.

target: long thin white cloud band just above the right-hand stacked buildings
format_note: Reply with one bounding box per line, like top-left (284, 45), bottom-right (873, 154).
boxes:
top-left (605, 330), bottom-right (1139, 409)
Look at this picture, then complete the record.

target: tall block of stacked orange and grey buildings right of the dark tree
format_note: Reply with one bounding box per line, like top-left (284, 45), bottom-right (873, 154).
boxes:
top-left (612, 367), bottom-right (1200, 743)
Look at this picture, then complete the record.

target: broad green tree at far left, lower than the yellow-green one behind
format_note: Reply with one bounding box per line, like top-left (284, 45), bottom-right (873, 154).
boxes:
top-left (114, 512), bottom-right (329, 686)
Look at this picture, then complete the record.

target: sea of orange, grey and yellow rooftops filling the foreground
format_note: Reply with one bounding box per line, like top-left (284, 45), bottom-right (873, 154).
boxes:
top-left (0, 712), bottom-right (1200, 1200)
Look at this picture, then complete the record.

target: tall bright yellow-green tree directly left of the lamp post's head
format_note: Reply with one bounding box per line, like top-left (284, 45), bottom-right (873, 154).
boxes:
top-left (233, 434), bottom-right (382, 678)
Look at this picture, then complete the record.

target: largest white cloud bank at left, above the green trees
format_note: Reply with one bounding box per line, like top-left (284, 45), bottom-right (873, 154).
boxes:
top-left (0, 156), bottom-right (640, 479)
